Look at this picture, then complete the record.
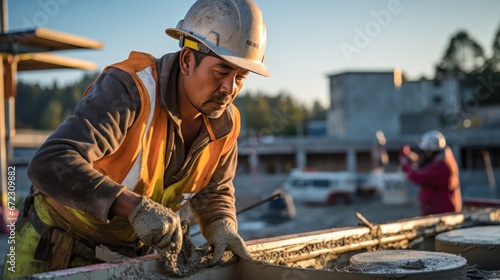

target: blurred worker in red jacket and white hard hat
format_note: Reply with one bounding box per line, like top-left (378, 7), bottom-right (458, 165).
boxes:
top-left (399, 130), bottom-right (462, 215)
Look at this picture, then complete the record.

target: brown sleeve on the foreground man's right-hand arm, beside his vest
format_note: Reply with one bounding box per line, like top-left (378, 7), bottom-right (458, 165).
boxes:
top-left (190, 142), bottom-right (238, 232)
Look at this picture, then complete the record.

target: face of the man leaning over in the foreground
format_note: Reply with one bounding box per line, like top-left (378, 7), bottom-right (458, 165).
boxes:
top-left (184, 50), bottom-right (248, 118)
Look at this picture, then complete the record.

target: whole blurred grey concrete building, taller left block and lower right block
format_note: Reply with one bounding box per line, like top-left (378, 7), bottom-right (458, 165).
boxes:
top-left (327, 72), bottom-right (460, 140)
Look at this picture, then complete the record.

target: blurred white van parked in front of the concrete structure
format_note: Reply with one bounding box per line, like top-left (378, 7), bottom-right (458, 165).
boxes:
top-left (283, 170), bottom-right (357, 204)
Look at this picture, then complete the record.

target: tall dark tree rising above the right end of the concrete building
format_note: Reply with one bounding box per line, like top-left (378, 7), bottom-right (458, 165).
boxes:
top-left (436, 31), bottom-right (486, 79)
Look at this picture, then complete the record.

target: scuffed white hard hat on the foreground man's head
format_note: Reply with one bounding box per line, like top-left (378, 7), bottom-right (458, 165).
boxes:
top-left (165, 0), bottom-right (269, 77)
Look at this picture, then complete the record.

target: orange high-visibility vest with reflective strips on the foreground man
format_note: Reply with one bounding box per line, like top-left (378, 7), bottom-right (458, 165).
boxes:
top-left (35, 52), bottom-right (240, 246)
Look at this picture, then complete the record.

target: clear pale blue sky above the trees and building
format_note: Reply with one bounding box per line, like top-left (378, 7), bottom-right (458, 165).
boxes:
top-left (8, 0), bottom-right (500, 105)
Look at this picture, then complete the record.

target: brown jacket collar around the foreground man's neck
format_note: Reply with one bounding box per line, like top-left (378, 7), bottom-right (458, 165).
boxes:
top-left (157, 51), bottom-right (234, 140)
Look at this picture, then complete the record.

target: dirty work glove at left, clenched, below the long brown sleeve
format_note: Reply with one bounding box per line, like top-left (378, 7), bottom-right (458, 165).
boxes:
top-left (128, 197), bottom-right (182, 254)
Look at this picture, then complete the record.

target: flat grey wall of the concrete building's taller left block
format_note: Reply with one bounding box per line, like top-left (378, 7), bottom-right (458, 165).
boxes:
top-left (328, 72), bottom-right (400, 139)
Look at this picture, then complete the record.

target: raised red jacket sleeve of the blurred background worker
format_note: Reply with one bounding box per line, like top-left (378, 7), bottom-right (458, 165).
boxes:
top-left (402, 161), bottom-right (450, 189)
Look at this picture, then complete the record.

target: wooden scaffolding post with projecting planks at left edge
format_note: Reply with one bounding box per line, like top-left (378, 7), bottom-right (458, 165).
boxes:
top-left (0, 0), bottom-right (103, 230)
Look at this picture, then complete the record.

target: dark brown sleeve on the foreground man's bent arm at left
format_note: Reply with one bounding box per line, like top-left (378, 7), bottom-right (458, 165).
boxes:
top-left (28, 69), bottom-right (140, 222)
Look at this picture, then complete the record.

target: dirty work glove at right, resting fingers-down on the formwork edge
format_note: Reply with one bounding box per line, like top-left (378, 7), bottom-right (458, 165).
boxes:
top-left (204, 220), bottom-right (252, 266)
